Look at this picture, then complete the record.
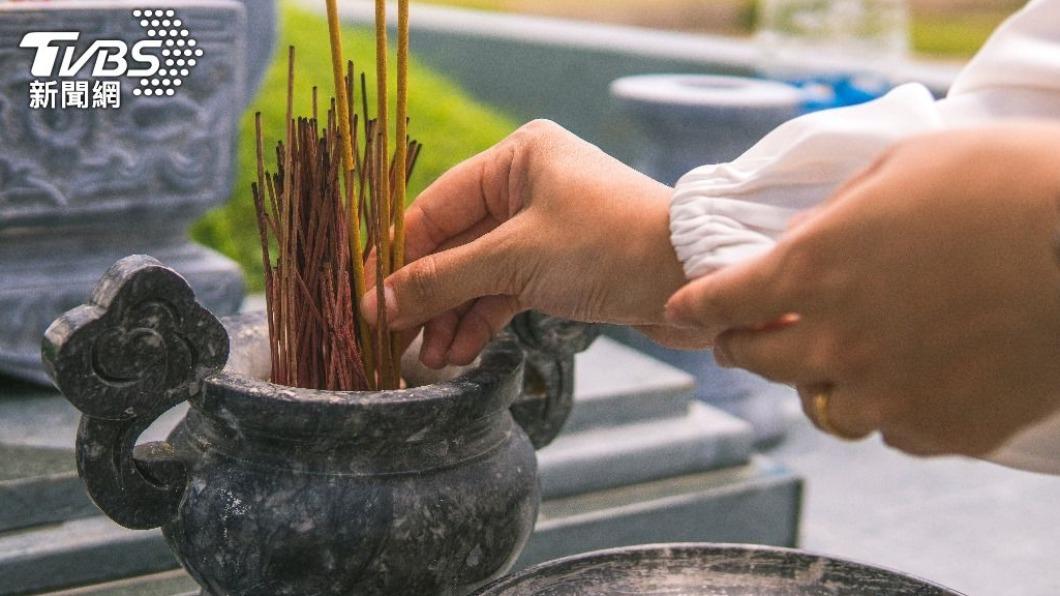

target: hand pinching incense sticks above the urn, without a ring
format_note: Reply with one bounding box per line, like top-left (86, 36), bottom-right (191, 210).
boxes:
top-left (361, 121), bottom-right (702, 368)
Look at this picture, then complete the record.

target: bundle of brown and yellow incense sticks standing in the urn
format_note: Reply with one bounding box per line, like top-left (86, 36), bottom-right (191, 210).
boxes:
top-left (251, 0), bottom-right (421, 390)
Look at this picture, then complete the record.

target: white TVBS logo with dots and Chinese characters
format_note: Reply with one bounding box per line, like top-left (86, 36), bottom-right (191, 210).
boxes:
top-left (19, 8), bottom-right (204, 109)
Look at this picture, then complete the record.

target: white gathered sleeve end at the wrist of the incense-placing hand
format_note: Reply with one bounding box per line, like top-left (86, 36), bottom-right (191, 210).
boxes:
top-left (670, 84), bottom-right (942, 279)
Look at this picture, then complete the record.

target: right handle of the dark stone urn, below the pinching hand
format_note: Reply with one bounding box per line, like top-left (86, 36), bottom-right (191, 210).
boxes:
top-left (509, 311), bottom-right (600, 449)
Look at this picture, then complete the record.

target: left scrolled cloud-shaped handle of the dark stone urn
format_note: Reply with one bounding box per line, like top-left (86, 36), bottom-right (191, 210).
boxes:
top-left (41, 256), bottom-right (228, 529)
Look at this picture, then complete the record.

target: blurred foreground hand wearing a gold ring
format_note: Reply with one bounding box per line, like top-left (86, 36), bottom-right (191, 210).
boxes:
top-left (668, 124), bottom-right (1060, 456)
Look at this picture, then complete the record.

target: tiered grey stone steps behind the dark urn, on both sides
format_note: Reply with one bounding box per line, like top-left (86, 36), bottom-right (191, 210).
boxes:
top-left (0, 338), bottom-right (801, 596)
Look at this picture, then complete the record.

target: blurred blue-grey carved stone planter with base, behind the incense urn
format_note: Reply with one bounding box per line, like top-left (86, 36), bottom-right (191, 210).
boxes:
top-left (0, 0), bottom-right (276, 383)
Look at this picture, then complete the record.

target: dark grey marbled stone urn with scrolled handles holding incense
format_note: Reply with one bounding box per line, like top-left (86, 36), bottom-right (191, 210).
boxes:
top-left (42, 252), bottom-right (591, 596)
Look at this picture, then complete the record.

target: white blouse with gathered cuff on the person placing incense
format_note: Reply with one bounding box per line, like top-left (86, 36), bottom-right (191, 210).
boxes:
top-left (670, 0), bottom-right (1060, 474)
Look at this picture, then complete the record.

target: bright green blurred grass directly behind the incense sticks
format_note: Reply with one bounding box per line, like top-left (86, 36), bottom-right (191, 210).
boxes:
top-left (192, 6), bottom-right (515, 291)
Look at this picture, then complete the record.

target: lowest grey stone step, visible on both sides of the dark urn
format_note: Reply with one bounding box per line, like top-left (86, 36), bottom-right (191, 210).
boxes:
top-left (8, 458), bottom-right (801, 596)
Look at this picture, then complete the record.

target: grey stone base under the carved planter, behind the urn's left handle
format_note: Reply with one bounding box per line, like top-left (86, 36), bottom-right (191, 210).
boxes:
top-left (0, 236), bottom-right (244, 386)
